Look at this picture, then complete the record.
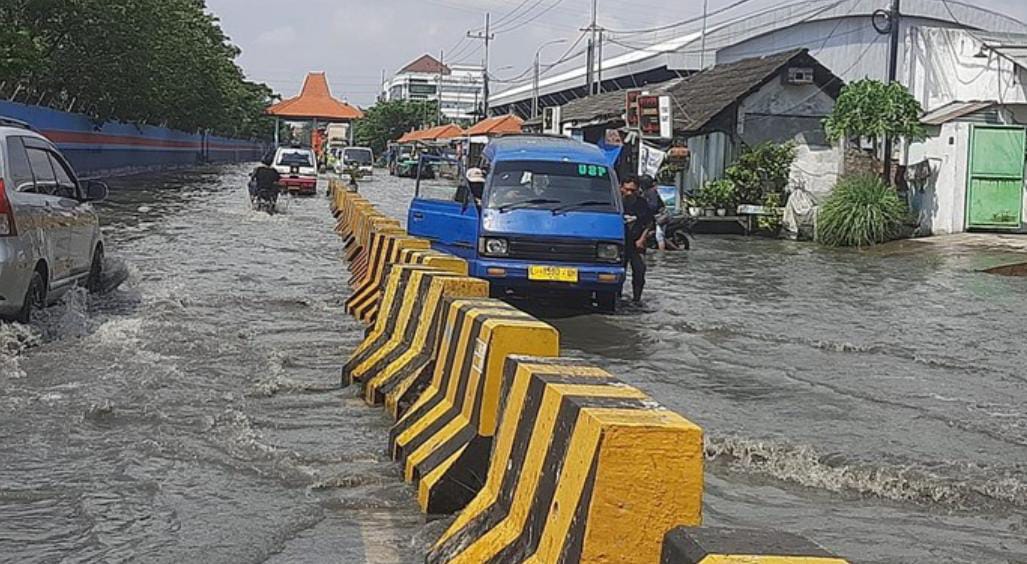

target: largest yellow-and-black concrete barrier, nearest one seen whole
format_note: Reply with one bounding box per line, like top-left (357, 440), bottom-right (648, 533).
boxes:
top-left (427, 356), bottom-right (703, 563)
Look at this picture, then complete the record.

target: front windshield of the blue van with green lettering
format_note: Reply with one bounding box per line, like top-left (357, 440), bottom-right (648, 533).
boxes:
top-left (485, 160), bottom-right (617, 212)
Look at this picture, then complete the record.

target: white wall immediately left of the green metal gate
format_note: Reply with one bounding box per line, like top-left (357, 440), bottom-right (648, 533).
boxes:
top-left (909, 121), bottom-right (971, 235)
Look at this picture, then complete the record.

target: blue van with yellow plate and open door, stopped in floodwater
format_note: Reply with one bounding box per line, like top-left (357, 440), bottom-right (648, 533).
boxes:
top-left (407, 136), bottom-right (624, 310)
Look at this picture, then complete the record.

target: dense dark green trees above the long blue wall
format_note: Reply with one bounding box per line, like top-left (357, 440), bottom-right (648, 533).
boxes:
top-left (0, 0), bottom-right (274, 138)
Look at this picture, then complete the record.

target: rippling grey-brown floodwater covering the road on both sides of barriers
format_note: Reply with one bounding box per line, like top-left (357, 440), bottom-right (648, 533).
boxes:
top-left (0, 166), bottom-right (1027, 563)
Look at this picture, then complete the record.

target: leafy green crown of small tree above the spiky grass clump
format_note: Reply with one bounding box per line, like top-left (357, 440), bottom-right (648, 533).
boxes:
top-left (824, 78), bottom-right (924, 141)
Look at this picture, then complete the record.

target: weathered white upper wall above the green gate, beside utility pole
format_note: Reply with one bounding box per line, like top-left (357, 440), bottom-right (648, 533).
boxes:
top-left (903, 27), bottom-right (1027, 111)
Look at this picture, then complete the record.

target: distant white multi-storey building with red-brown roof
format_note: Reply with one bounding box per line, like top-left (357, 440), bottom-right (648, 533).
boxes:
top-left (383, 54), bottom-right (485, 121)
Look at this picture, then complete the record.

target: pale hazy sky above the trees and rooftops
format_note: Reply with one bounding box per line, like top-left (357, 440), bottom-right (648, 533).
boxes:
top-left (207, 0), bottom-right (1027, 105)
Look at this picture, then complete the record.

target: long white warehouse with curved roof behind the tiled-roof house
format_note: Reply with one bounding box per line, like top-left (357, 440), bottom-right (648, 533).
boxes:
top-left (489, 0), bottom-right (1027, 116)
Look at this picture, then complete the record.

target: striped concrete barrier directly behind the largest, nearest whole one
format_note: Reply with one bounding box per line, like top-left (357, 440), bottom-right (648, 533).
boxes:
top-left (390, 300), bottom-right (560, 514)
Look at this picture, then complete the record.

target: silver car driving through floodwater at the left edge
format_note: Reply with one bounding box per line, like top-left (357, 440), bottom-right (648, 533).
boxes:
top-left (0, 116), bottom-right (108, 323)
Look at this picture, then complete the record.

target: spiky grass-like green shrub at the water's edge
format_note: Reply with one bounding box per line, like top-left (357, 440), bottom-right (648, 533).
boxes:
top-left (816, 174), bottom-right (907, 247)
